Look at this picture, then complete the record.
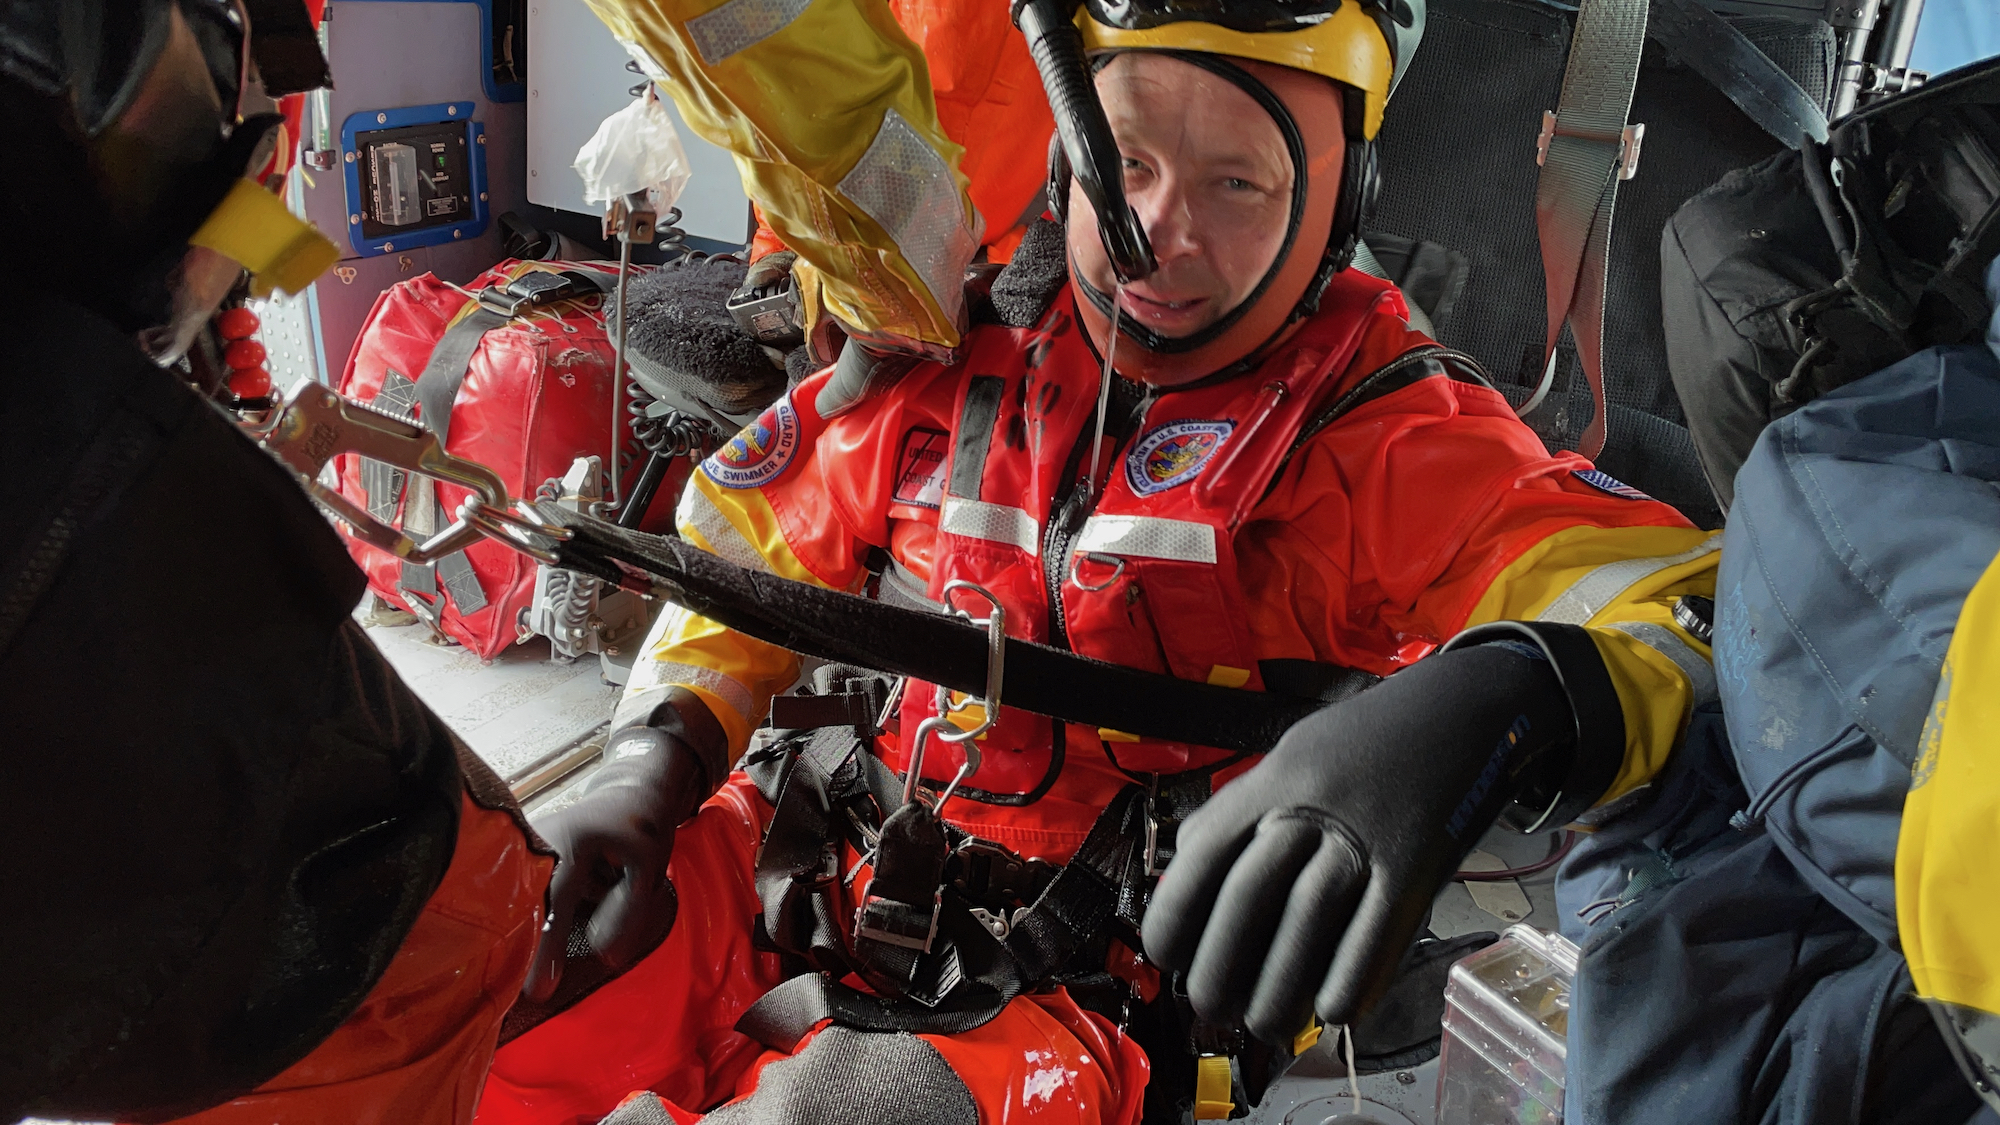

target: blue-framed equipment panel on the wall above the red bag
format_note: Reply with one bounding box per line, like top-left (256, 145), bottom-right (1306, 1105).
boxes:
top-left (340, 102), bottom-right (488, 258)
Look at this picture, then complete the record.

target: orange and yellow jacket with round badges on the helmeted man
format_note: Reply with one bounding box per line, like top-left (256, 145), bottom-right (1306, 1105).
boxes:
top-left (618, 270), bottom-right (1718, 861)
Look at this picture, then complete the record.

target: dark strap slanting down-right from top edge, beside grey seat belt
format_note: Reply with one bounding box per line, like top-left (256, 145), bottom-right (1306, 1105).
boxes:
top-left (1646, 0), bottom-right (1826, 148)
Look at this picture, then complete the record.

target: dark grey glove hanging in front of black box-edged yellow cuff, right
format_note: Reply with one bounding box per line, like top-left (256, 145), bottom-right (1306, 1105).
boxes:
top-left (1144, 623), bottom-right (1624, 1043)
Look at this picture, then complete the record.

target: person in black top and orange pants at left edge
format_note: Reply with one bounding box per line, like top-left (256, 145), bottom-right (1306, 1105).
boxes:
top-left (0, 0), bottom-right (554, 1125)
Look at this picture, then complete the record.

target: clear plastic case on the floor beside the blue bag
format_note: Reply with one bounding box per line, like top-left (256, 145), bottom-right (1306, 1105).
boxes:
top-left (1438, 925), bottom-right (1576, 1125)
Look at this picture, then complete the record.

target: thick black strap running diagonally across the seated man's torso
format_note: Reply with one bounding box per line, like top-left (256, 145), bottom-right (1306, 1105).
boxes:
top-left (528, 504), bottom-right (1324, 753)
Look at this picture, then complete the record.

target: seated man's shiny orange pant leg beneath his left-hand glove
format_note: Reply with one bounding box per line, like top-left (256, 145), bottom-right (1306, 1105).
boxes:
top-left (478, 775), bottom-right (782, 1125)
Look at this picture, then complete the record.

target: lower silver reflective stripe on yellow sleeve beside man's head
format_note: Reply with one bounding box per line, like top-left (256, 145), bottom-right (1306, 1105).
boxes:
top-left (838, 110), bottom-right (976, 322)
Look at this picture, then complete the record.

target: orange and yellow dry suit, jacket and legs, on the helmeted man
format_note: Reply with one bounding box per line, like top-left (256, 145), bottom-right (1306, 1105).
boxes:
top-left (480, 262), bottom-right (1716, 1125)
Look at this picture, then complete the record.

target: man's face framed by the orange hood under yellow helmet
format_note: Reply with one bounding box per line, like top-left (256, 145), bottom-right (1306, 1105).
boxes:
top-left (1068, 52), bottom-right (1294, 338)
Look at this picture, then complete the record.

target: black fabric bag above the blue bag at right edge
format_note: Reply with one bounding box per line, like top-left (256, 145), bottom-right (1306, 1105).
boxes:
top-left (1660, 60), bottom-right (2000, 504)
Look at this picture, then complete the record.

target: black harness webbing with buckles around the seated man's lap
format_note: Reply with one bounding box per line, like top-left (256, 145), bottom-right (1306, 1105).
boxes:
top-left (736, 691), bottom-right (1234, 1051)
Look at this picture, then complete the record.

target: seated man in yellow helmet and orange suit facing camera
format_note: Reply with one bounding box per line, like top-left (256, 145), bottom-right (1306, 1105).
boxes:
top-left (480, 0), bottom-right (1716, 1125)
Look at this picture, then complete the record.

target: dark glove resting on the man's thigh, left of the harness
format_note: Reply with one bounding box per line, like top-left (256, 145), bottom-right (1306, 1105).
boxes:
top-left (522, 691), bottom-right (728, 1001)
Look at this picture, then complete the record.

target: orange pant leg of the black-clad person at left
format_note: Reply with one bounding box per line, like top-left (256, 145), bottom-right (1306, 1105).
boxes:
top-left (154, 797), bottom-right (554, 1125)
